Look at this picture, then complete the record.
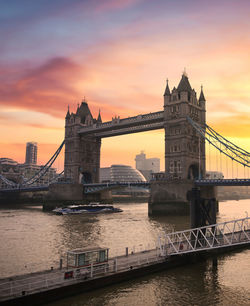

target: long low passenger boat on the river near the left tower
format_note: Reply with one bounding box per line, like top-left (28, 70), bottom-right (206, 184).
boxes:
top-left (53, 203), bottom-right (123, 215)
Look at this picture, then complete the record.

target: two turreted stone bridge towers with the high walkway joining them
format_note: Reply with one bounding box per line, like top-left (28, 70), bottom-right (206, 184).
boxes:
top-left (64, 73), bottom-right (206, 183)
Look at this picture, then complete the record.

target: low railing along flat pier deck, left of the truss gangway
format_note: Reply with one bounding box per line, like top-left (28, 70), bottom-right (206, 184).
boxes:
top-left (0, 249), bottom-right (165, 301)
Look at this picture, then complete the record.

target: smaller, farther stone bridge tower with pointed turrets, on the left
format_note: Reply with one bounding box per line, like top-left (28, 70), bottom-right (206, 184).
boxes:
top-left (64, 100), bottom-right (101, 184)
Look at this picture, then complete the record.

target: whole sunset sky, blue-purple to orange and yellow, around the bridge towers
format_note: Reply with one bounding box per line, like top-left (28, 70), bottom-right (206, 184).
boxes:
top-left (0, 0), bottom-right (250, 176)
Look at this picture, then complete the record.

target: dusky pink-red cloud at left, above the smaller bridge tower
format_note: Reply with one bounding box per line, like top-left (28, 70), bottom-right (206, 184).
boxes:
top-left (0, 58), bottom-right (83, 116)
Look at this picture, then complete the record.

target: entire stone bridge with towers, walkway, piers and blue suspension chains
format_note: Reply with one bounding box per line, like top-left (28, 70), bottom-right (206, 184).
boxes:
top-left (0, 72), bottom-right (250, 227)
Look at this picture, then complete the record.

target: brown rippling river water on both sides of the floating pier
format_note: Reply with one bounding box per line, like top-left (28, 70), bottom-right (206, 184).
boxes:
top-left (0, 200), bottom-right (250, 306)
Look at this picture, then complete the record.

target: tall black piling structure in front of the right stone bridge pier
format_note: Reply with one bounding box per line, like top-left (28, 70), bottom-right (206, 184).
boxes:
top-left (188, 188), bottom-right (217, 228)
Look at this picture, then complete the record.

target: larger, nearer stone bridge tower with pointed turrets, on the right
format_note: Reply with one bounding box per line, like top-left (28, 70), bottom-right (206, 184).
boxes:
top-left (164, 71), bottom-right (206, 180)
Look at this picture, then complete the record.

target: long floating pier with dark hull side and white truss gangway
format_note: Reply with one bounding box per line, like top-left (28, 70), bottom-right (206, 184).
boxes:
top-left (0, 217), bottom-right (250, 305)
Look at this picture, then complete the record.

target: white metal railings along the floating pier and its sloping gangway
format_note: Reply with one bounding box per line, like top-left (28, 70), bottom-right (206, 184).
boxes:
top-left (0, 217), bottom-right (250, 301)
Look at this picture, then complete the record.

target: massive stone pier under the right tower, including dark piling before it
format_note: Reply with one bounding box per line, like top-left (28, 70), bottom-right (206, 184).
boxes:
top-left (148, 179), bottom-right (217, 222)
